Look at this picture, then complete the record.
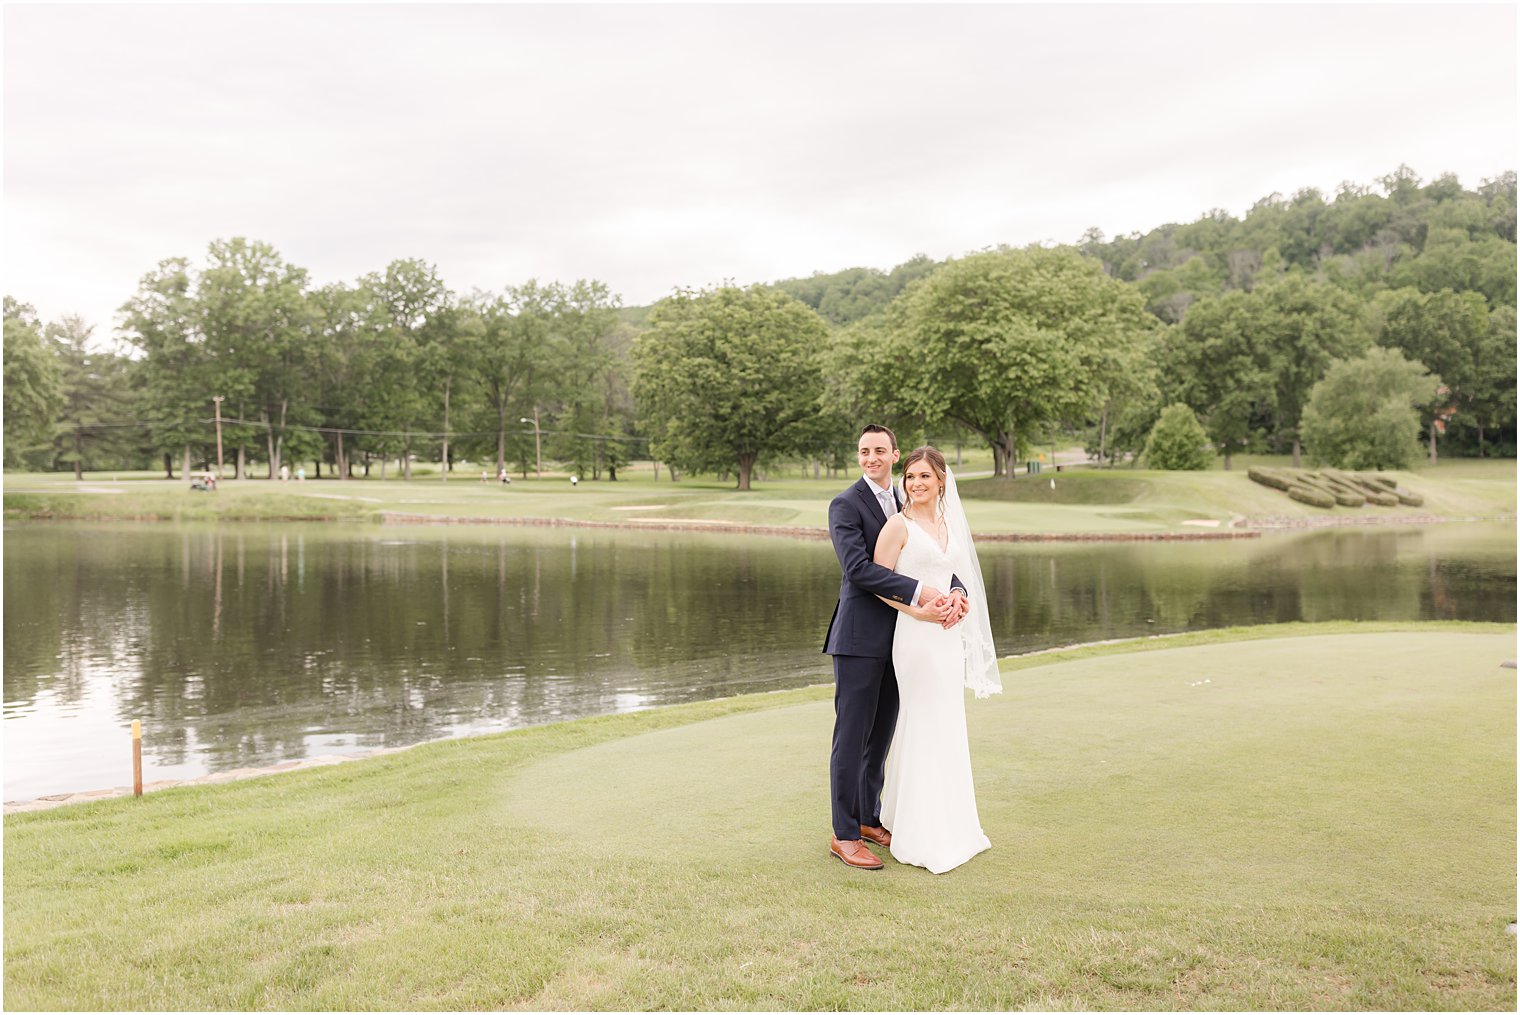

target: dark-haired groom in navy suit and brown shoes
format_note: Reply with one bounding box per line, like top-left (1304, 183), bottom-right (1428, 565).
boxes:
top-left (824, 424), bottom-right (967, 871)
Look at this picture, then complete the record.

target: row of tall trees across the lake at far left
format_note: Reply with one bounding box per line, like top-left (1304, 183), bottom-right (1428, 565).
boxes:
top-left (5, 247), bottom-right (638, 479)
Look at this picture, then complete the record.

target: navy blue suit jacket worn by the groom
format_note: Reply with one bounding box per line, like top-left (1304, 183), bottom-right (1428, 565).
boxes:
top-left (824, 477), bottom-right (918, 659)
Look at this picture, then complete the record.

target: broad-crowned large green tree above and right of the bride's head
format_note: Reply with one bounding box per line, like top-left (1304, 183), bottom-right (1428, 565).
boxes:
top-left (872, 246), bottom-right (1155, 476)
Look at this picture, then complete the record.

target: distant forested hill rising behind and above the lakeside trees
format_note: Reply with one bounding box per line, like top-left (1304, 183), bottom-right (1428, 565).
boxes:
top-left (625, 166), bottom-right (1515, 325)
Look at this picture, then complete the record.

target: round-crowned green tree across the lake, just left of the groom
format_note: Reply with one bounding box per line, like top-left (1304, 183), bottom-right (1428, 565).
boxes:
top-left (634, 286), bottom-right (828, 491)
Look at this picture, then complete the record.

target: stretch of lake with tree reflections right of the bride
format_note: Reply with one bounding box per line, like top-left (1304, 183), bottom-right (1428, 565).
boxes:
top-left (982, 527), bottom-right (1515, 653)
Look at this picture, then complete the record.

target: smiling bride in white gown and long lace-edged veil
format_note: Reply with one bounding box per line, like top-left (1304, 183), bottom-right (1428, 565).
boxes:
top-left (876, 445), bottom-right (1003, 874)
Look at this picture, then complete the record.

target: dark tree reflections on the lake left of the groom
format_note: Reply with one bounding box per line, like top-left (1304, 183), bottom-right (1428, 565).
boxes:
top-left (5, 529), bottom-right (836, 767)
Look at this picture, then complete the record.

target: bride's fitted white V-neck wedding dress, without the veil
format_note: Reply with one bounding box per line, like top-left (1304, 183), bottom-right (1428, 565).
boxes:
top-left (882, 518), bottom-right (993, 874)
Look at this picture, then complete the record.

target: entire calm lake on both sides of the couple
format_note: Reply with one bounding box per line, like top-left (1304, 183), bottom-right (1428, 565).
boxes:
top-left (3, 523), bottom-right (1515, 799)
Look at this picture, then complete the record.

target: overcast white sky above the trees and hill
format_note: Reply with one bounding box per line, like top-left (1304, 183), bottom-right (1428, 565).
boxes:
top-left (3, 5), bottom-right (1517, 343)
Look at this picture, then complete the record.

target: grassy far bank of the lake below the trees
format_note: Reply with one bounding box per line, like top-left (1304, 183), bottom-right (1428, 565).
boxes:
top-left (5, 459), bottom-right (1515, 533)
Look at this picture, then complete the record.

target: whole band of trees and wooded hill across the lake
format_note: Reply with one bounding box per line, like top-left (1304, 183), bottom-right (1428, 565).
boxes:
top-left (5, 167), bottom-right (1515, 488)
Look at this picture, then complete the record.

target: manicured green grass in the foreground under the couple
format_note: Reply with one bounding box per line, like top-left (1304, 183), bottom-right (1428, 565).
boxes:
top-left (5, 624), bottom-right (1515, 1010)
